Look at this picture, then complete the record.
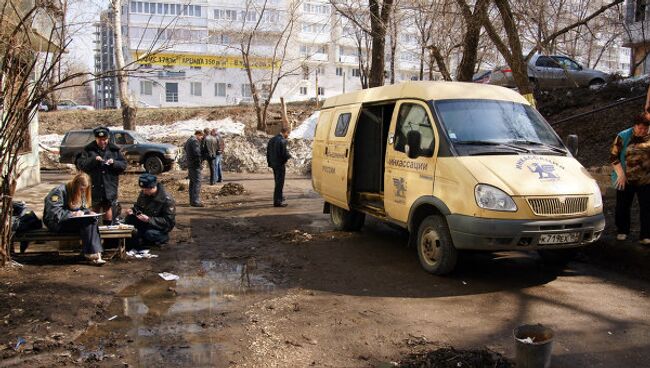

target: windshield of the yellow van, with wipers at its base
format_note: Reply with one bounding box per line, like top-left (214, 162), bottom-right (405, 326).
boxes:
top-left (434, 100), bottom-right (567, 155)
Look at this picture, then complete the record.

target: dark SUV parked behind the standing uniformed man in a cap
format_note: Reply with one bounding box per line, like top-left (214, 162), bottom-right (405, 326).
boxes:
top-left (59, 129), bottom-right (178, 174)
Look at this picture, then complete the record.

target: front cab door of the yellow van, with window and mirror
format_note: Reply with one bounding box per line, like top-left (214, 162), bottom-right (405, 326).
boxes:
top-left (384, 100), bottom-right (439, 223)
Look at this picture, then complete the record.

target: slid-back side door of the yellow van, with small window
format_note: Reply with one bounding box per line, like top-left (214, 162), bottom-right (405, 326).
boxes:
top-left (321, 104), bottom-right (361, 209)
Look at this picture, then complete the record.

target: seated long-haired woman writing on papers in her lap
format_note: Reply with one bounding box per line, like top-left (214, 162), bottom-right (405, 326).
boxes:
top-left (43, 173), bottom-right (106, 265)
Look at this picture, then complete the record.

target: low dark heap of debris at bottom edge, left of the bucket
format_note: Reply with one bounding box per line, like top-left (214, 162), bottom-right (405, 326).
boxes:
top-left (397, 347), bottom-right (514, 368)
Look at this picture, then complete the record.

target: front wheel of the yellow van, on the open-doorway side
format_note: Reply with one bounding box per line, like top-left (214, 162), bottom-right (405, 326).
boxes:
top-left (417, 215), bottom-right (458, 275)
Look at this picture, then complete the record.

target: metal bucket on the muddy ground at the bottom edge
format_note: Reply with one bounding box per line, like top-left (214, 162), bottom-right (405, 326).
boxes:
top-left (512, 324), bottom-right (555, 368)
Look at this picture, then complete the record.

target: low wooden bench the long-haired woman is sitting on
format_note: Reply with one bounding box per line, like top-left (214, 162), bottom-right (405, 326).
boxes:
top-left (11, 226), bottom-right (133, 259)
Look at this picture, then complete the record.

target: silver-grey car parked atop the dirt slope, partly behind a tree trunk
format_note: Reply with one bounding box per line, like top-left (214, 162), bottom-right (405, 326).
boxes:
top-left (489, 55), bottom-right (611, 89)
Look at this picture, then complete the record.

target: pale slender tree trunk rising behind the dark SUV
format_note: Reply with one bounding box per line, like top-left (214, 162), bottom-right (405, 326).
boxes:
top-left (111, 0), bottom-right (137, 130)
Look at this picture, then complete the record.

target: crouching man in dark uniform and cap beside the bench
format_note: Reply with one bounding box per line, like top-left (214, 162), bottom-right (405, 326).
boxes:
top-left (124, 173), bottom-right (176, 248)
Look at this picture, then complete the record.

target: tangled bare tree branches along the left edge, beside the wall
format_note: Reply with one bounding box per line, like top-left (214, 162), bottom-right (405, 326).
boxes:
top-left (0, 0), bottom-right (80, 266)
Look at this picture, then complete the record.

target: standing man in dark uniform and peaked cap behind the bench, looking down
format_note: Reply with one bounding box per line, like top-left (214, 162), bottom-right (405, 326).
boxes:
top-left (81, 127), bottom-right (127, 224)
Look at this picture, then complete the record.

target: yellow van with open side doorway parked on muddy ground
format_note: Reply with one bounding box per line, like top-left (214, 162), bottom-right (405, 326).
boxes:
top-left (312, 82), bottom-right (605, 274)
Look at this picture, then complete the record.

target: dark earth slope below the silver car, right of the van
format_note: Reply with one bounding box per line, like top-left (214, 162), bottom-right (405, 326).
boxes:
top-left (536, 78), bottom-right (648, 167)
